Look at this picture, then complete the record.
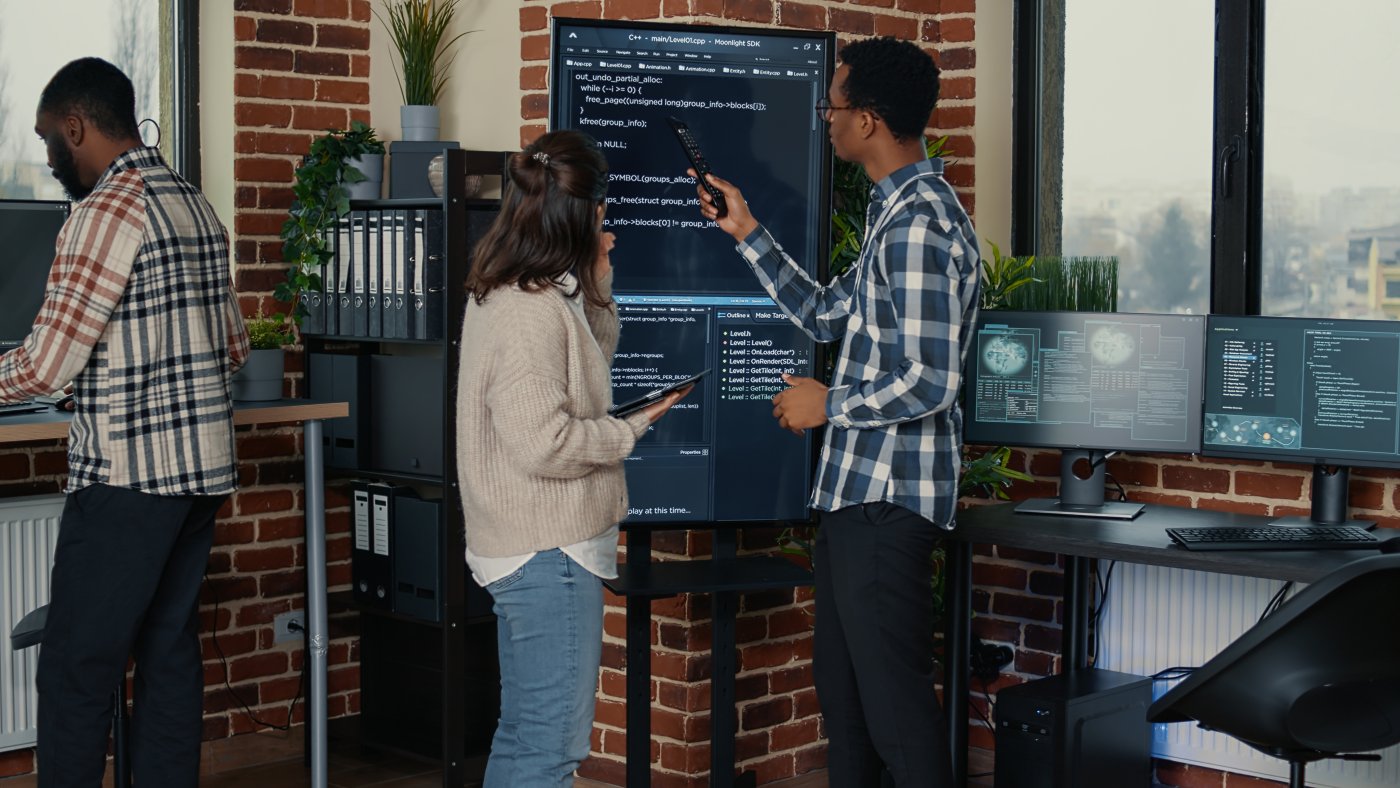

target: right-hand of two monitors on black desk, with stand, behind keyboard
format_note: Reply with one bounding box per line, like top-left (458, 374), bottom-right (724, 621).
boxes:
top-left (1201, 315), bottom-right (1400, 525)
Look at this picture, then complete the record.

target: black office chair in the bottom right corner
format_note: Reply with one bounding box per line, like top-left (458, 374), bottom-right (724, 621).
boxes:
top-left (1148, 554), bottom-right (1400, 788)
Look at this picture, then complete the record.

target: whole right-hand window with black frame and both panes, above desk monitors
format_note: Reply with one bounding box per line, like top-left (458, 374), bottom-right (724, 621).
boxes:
top-left (1012, 0), bottom-right (1400, 318)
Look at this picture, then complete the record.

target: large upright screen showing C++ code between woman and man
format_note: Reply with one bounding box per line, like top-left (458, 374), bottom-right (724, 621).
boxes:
top-left (549, 17), bottom-right (836, 528)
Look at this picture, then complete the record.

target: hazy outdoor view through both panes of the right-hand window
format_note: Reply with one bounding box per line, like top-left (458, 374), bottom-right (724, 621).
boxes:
top-left (1042, 0), bottom-right (1400, 318)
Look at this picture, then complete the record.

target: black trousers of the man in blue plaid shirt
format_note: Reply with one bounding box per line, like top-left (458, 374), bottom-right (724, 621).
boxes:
top-left (813, 502), bottom-right (953, 788)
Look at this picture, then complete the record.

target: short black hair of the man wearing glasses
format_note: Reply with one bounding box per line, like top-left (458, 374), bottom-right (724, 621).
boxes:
top-left (841, 38), bottom-right (938, 140)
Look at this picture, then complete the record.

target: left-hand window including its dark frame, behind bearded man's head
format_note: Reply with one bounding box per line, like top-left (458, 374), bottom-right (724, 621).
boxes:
top-left (0, 0), bottom-right (199, 200)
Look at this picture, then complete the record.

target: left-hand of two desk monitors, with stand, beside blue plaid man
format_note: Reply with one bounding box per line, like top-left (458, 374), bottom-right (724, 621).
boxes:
top-left (963, 311), bottom-right (1205, 519)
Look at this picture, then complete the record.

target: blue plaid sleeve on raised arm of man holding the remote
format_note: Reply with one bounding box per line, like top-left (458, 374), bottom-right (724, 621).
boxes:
top-left (735, 224), bottom-right (855, 342)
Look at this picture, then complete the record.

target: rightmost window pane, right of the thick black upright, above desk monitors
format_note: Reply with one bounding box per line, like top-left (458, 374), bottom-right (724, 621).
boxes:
top-left (1260, 0), bottom-right (1400, 318)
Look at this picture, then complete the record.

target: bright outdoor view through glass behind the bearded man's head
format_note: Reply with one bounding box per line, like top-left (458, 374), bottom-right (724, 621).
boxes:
top-left (0, 0), bottom-right (163, 200)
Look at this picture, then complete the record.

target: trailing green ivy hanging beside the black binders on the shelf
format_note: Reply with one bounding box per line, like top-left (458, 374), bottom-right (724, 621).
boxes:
top-left (273, 120), bottom-right (384, 326)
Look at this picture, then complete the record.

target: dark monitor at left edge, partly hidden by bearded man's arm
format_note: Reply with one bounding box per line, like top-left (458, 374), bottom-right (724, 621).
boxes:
top-left (0, 200), bottom-right (69, 353)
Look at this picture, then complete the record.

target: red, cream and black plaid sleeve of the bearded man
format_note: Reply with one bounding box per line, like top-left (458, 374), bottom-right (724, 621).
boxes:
top-left (0, 175), bottom-right (146, 402)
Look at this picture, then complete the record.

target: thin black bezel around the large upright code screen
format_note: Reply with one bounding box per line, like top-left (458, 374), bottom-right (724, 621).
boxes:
top-left (546, 17), bottom-right (837, 530)
